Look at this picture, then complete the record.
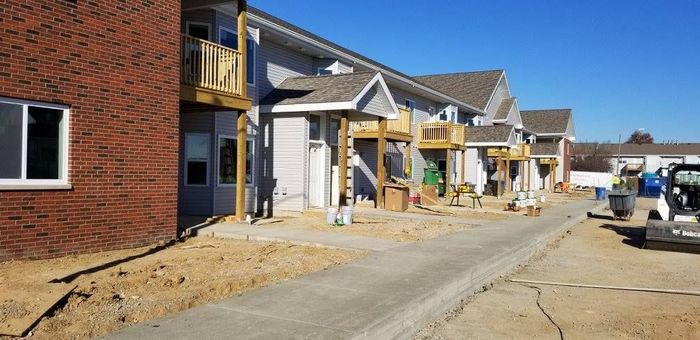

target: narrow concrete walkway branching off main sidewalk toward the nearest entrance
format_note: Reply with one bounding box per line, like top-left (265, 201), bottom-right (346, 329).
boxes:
top-left (192, 223), bottom-right (405, 251)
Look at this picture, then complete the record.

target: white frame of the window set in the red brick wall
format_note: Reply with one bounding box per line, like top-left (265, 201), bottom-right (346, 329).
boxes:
top-left (0, 97), bottom-right (72, 190)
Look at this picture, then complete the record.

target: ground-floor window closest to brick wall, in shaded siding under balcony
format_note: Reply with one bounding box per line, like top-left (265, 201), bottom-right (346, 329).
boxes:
top-left (185, 133), bottom-right (210, 186)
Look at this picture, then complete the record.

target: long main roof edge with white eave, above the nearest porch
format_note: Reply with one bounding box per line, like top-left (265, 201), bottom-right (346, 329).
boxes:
top-left (248, 6), bottom-right (484, 115)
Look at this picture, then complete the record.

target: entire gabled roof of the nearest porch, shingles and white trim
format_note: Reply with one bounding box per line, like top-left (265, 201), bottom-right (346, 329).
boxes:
top-left (260, 71), bottom-right (399, 116)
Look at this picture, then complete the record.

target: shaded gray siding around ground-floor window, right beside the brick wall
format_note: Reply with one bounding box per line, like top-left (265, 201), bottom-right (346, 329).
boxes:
top-left (178, 113), bottom-right (216, 216)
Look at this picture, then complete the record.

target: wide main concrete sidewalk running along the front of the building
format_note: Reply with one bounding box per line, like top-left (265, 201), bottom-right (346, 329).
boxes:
top-left (106, 201), bottom-right (604, 339)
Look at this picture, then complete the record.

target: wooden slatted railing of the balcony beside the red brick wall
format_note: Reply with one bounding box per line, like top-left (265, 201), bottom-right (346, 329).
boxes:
top-left (180, 34), bottom-right (243, 96)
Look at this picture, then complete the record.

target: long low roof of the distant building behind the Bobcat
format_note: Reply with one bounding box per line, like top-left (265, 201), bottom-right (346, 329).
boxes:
top-left (572, 143), bottom-right (700, 156)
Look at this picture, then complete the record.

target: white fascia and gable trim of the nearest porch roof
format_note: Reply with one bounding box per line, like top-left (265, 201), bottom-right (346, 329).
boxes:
top-left (260, 73), bottom-right (401, 119)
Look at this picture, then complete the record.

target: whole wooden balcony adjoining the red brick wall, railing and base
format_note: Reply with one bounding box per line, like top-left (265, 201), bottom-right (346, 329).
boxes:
top-left (180, 34), bottom-right (251, 110)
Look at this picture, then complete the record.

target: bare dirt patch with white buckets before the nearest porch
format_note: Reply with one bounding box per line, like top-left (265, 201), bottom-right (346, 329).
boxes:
top-left (258, 210), bottom-right (470, 242)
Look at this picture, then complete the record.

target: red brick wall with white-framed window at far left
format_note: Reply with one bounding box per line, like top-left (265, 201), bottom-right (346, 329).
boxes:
top-left (0, 0), bottom-right (180, 261)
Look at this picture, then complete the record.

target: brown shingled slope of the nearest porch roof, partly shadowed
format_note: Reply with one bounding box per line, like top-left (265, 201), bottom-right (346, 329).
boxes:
top-left (260, 71), bottom-right (379, 105)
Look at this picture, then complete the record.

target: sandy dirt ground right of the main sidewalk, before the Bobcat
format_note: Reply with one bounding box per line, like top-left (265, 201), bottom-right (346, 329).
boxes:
top-left (415, 199), bottom-right (700, 339)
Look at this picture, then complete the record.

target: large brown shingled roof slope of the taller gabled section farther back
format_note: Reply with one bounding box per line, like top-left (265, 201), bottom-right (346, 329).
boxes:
top-left (414, 70), bottom-right (504, 110)
